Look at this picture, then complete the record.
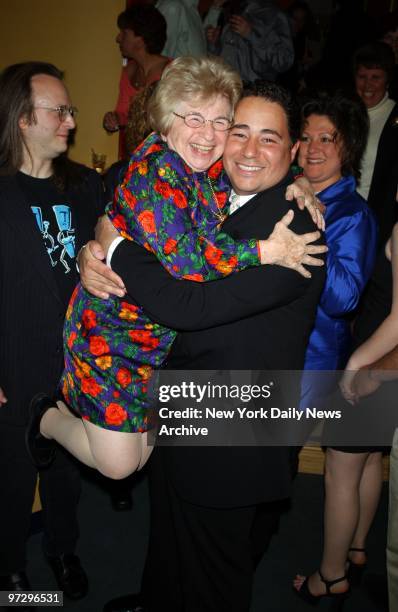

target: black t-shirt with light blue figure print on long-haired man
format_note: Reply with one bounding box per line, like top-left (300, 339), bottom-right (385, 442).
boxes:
top-left (17, 172), bottom-right (78, 304)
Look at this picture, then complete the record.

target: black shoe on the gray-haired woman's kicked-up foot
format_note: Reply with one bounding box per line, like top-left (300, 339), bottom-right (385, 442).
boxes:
top-left (25, 393), bottom-right (56, 468)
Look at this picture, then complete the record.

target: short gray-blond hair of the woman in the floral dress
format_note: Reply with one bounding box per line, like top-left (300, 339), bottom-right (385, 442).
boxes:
top-left (148, 57), bottom-right (242, 135)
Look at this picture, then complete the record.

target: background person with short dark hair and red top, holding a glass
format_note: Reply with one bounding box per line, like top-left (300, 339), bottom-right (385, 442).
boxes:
top-left (103, 4), bottom-right (170, 159)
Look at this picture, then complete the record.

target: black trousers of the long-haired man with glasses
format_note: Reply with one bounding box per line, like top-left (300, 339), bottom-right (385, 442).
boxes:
top-left (0, 422), bottom-right (80, 575)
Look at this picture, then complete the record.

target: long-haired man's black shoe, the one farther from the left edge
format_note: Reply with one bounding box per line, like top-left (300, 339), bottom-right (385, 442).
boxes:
top-left (47, 555), bottom-right (88, 599)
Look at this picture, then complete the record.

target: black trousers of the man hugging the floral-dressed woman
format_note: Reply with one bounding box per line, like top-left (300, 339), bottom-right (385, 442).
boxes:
top-left (142, 448), bottom-right (280, 612)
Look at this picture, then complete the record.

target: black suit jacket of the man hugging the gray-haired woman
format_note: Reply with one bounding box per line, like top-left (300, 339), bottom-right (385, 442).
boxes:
top-left (112, 175), bottom-right (325, 507)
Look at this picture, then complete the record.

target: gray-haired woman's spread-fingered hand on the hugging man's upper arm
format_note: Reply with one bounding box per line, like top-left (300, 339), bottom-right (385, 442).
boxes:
top-left (259, 210), bottom-right (328, 278)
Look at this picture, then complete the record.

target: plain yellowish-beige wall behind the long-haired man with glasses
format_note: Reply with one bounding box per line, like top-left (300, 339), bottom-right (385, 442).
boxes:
top-left (0, 0), bottom-right (126, 165)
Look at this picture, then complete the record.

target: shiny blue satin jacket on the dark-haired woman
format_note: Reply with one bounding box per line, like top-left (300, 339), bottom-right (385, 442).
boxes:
top-left (304, 176), bottom-right (377, 370)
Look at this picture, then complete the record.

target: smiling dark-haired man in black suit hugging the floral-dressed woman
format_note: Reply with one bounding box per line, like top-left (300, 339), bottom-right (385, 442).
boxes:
top-left (82, 85), bottom-right (324, 612)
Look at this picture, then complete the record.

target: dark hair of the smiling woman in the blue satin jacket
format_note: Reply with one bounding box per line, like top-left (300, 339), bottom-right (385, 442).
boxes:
top-left (301, 90), bottom-right (369, 181)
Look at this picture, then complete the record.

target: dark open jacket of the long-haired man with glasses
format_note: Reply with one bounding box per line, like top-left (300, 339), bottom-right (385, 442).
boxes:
top-left (0, 168), bottom-right (104, 426)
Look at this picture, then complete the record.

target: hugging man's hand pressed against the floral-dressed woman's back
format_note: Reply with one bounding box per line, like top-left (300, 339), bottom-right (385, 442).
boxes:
top-left (78, 240), bottom-right (126, 299)
